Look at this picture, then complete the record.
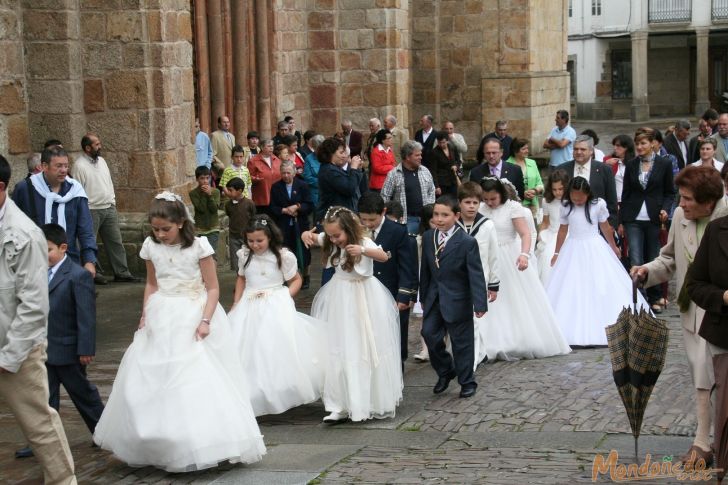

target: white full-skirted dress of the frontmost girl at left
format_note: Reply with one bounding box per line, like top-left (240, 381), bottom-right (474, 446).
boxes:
top-left (94, 237), bottom-right (265, 472)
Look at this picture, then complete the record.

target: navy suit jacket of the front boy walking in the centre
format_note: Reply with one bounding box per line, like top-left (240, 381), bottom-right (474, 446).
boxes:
top-left (420, 229), bottom-right (488, 322)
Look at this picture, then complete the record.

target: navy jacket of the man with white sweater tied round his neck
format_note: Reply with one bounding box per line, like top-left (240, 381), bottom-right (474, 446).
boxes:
top-left (13, 179), bottom-right (98, 264)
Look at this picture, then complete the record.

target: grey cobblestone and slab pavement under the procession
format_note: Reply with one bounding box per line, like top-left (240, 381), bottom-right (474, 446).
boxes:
top-left (0, 234), bottom-right (716, 484)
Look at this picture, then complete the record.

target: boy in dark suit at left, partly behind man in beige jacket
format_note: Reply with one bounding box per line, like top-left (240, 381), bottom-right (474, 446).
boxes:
top-left (42, 224), bottom-right (104, 434)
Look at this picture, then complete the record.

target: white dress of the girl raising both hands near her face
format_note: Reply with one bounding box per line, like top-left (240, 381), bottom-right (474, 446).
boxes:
top-left (311, 233), bottom-right (403, 421)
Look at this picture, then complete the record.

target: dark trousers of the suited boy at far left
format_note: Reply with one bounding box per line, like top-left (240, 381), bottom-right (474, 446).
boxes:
top-left (46, 363), bottom-right (104, 434)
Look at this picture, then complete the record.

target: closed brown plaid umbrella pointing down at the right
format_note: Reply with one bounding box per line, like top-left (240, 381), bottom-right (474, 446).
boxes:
top-left (606, 282), bottom-right (668, 460)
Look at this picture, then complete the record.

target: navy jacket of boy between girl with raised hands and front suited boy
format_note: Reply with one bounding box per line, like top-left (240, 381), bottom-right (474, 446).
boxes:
top-left (374, 217), bottom-right (417, 303)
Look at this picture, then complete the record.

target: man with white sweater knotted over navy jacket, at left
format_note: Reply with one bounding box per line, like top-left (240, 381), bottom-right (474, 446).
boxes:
top-left (13, 147), bottom-right (97, 276)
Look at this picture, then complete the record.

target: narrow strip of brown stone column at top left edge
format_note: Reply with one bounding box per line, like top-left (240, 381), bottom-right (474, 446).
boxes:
top-left (0, 2), bottom-right (30, 181)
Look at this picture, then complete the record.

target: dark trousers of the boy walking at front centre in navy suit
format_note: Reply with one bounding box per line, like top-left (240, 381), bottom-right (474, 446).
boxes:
top-left (422, 299), bottom-right (478, 387)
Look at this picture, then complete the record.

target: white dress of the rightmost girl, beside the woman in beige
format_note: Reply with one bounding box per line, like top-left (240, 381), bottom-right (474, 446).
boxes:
top-left (546, 199), bottom-right (649, 346)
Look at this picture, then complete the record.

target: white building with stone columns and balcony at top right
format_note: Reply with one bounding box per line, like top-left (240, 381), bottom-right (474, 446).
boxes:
top-left (567, 0), bottom-right (728, 121)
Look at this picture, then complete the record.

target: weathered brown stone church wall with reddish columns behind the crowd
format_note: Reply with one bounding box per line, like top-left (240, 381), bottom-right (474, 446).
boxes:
top-left (0, 0), bottom-right (569, 207)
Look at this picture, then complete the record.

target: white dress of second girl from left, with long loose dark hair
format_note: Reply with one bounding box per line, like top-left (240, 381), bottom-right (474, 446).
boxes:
top-left (228, 247), bottom-right (326, 416)
